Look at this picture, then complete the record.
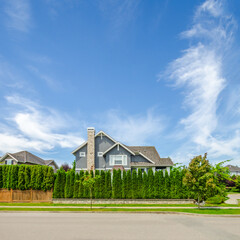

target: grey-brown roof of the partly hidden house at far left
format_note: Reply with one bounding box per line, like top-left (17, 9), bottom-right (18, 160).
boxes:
top-left (1, 151), bottom-right (58, 168)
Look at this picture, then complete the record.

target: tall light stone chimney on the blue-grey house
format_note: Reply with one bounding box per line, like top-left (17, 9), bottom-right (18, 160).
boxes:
top-left (87, 127), bottom-right (95, 171)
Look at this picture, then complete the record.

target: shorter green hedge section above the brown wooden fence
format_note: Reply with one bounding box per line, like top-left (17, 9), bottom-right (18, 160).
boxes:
top-left (0, 165), bottom-right (54, 191)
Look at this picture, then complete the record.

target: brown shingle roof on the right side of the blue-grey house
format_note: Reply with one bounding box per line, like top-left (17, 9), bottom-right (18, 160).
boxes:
top-left (126, 146), bottom-right (173, 167)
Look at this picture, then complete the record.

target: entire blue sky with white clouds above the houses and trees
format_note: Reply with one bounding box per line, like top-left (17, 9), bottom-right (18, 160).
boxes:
top-left (0, 0), bottom-right (240, 167)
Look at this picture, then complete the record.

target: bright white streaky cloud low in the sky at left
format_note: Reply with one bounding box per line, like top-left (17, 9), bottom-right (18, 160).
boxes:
top-left (0, 96), bottom-right (84, 153)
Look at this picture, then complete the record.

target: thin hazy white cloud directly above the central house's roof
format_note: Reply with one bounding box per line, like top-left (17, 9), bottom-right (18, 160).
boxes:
top-left (101, 110), bottom-right (166, 145)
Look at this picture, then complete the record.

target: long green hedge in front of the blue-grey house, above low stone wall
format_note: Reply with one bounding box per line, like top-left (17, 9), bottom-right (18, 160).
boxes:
top-left (52, 168), bottom-right (193, 199)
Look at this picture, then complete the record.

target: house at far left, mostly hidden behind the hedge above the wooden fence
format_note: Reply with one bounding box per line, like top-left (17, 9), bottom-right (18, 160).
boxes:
top-left (0, 151), bottom-right (58, 172)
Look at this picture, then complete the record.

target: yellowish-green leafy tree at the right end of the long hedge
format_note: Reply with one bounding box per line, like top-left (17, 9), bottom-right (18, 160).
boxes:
top-left (183, 153), bottom-right (216, 208)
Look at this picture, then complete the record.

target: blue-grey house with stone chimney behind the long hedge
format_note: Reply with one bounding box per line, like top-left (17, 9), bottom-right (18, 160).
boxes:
top-left (72, 128), bottom-right (173, 172)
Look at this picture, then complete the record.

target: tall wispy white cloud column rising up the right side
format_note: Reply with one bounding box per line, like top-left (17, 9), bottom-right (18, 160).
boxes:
top-left (163, 0), bottom-right (240, 163)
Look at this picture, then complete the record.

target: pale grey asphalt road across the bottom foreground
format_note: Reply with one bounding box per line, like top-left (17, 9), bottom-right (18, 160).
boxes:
top-left (0, 212), bottom-right (240, 240)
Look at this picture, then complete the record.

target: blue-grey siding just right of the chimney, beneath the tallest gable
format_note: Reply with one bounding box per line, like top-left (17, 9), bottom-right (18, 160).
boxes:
top-left (95, 136), bottom-right (115, 169)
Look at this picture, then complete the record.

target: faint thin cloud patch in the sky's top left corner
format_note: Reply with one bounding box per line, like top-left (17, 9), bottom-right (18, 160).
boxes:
top-left (5, 0), bottom-right (31, 32)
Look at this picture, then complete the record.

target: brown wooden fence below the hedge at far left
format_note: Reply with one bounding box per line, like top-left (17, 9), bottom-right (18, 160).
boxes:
top-left (0, 189), bottom-right (52, 203)
